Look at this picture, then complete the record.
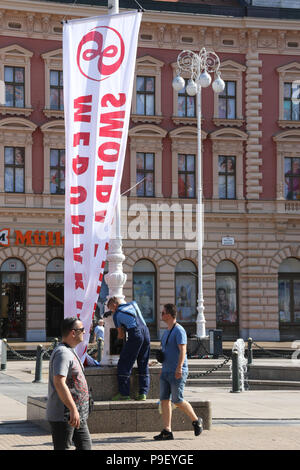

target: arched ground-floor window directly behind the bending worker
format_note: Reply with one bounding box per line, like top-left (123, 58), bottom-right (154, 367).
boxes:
top-left (133, 259), bottom-right (156, 333)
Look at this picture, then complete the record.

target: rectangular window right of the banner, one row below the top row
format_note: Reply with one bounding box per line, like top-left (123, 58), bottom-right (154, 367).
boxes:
top-left (136, 152), bottom-right (154, 197)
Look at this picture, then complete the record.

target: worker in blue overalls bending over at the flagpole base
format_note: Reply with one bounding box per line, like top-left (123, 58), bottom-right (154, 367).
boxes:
top-left (107, 297), bottom-right (150, 401)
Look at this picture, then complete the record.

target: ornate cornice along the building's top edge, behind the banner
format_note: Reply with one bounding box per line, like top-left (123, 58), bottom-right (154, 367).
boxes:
top-left (0, 0), bottom-right (300, 55)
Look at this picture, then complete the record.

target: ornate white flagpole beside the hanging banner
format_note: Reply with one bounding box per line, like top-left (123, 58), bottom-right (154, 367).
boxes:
top-left (101, 0), bottom-right (127, 365)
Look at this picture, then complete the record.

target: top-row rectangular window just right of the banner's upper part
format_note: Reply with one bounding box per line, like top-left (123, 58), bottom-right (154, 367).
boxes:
top-left (136, 76), bottom-right (155, 116)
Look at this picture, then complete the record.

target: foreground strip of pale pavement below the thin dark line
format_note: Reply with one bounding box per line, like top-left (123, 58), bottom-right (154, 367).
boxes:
top-left (0, 422), bottom-right (300, 452)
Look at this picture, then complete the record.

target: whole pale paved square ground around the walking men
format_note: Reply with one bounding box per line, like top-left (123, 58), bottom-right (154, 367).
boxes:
top-left (0, 361), bottom-right (300, 455)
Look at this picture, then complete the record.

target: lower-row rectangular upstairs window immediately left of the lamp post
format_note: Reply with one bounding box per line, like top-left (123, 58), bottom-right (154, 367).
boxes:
top-left (178, 154), bottom-right (196, 198)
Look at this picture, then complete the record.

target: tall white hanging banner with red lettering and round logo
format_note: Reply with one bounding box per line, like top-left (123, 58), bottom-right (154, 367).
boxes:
top-left (63, 12), bottom-right (142, 361)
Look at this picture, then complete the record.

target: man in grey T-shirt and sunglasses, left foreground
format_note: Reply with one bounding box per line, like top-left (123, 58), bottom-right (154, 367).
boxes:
top-left (47, 317), bottom-right (91, 450)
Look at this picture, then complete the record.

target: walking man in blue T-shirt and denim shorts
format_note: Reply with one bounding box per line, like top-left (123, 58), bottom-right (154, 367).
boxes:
top-left (154, 304), bottom-right (203, 441)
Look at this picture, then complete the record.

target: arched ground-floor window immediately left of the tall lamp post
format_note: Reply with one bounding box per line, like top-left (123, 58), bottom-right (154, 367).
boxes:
top-left (175, 259), bottom-right (198, 323)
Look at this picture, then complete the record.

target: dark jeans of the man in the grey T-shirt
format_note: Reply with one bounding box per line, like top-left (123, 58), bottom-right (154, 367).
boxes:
top-left (49, 421), bottom-right (92, 450)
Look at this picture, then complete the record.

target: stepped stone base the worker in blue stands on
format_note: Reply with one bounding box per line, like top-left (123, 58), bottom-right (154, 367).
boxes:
top-left (27, 366), bottom-right (212, 433)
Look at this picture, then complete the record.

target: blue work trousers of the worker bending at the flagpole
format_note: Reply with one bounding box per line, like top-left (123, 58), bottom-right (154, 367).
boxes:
top-left (118, 325), bottom-right (150, 396)
